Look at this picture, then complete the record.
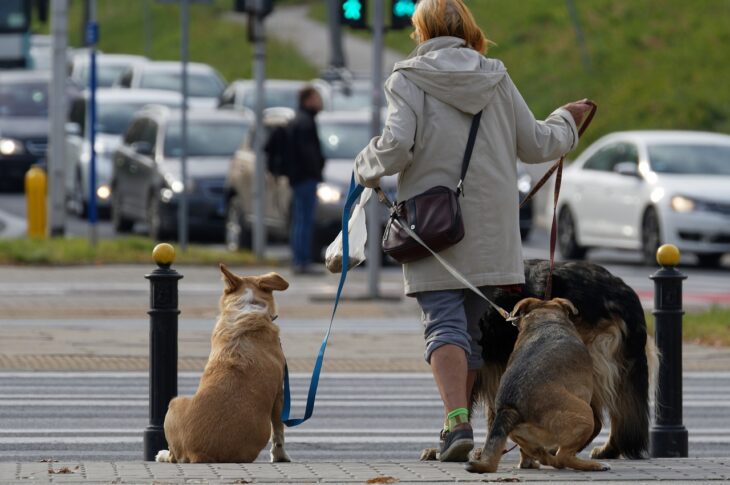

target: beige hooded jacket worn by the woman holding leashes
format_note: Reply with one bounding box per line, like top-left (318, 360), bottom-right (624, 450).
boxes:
top-left (355, 37), bottom-right (578, 295)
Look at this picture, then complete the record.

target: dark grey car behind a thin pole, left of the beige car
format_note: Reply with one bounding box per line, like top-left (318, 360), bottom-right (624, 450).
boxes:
top-left (111, 106), bottom-right (251, 239)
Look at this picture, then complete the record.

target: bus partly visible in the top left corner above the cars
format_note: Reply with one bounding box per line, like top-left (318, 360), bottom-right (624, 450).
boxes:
top-left (0, 0), bottom-right (33, 69)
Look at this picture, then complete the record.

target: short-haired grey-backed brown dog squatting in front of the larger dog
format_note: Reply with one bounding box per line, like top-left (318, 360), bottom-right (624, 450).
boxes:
top-left (467, 298), bottom-right (609, 473)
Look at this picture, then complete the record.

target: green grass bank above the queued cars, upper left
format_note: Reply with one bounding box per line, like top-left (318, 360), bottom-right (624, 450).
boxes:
top-left (36, 0), bottom-right (318, 81)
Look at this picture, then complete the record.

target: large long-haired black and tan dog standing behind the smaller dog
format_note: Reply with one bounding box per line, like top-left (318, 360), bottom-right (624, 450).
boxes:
top-left (421, 260), bottom-right (658, 460)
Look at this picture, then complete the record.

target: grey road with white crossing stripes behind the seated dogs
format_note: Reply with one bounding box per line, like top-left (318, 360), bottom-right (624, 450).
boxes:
top-left (0, 373), bottom-right (730, 462)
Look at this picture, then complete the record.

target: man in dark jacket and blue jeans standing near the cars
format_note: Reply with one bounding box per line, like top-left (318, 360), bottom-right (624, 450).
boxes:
top-left (288, 86), bottom-right (324, 273)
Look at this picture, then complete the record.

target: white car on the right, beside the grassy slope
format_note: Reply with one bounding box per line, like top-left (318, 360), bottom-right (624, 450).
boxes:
top-left (548, 131), bottom-right (730, 266)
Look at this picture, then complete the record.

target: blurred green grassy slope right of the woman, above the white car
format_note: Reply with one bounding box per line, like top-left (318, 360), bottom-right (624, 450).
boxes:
top-left (311, 0), bottom-right (730, 148)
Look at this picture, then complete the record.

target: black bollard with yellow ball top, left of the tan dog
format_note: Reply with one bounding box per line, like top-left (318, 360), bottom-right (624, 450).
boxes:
top-left (144, 244), bottom-right (182, 461)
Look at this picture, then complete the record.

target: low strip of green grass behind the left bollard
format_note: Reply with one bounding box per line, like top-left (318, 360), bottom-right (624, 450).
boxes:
top-left (0, 237), bottom-right (262, 265)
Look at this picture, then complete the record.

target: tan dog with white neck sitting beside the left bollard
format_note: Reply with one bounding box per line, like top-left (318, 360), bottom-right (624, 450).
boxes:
top-left (156, 265), bottom-right (290, 463)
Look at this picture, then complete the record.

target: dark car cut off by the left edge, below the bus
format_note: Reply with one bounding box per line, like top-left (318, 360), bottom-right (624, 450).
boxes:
top-left (0, 71), bottom-right (50, 191)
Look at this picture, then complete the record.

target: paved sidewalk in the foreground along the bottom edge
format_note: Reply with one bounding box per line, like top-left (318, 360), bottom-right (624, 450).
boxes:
top-left (0, 458), bottom-right (730, 485)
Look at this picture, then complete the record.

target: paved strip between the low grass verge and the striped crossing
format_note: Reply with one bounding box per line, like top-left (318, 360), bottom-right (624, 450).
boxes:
top-left (0, 264), bottom-right (730, 372)
